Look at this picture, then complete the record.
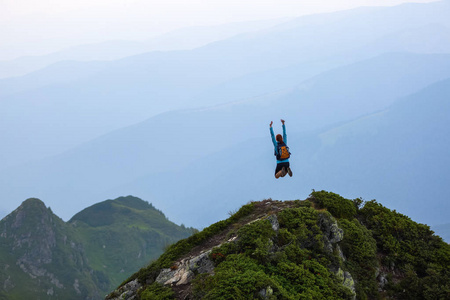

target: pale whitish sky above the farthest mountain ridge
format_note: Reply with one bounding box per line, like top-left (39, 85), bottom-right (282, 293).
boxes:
top-left (0, 0), bottom-right (431, 60)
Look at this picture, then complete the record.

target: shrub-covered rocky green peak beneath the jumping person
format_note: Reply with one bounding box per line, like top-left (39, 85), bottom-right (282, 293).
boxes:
top-left (106, 191), bottom-right (450, 300)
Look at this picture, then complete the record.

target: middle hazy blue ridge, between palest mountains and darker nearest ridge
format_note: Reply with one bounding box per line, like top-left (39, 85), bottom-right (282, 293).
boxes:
top-left (1, 54), bottom-right (450, 226)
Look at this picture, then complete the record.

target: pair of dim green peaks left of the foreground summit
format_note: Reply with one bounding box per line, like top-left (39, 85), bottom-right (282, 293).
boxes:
top-left (0, 196), bottom-right (193, 299)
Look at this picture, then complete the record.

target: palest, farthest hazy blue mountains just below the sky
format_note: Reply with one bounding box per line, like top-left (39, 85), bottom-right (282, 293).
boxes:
top-left (0, 2), bottom-right (450, 171)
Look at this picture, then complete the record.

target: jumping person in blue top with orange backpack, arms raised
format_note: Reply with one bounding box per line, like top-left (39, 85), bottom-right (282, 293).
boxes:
top-left (270, 119), bottom-right (292, 179)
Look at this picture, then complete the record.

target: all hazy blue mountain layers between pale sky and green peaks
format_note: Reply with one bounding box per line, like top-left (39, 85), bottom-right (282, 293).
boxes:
top-left (0, 1), bottom-right (450, 234)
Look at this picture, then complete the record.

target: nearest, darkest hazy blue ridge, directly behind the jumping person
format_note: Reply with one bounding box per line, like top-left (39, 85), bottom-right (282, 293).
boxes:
top-left (118, 79), bottom-right (450, 226)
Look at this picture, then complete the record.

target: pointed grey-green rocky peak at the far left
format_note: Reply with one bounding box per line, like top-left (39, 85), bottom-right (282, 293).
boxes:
top-left (0, 199), bottom-right (102, 299)
